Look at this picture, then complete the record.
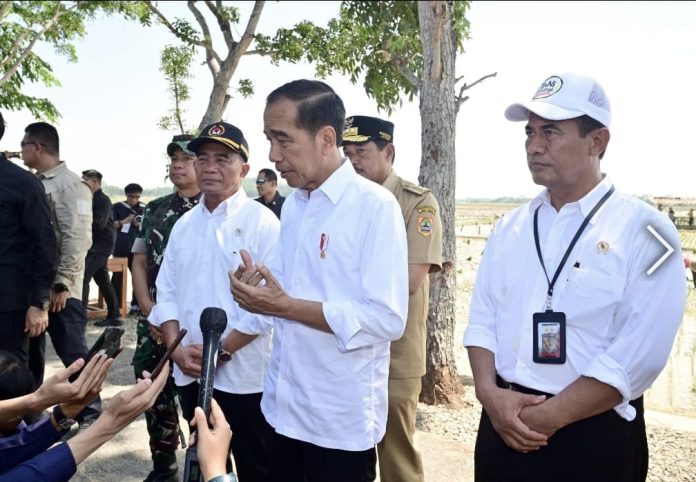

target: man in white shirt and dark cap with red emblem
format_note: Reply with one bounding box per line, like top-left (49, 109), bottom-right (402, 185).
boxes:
top-left (148, 122), bottom-right (280, 482)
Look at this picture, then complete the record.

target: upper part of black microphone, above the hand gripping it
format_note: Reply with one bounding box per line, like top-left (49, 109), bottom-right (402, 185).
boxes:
top-left (198, 308), bottom-right (227, 418)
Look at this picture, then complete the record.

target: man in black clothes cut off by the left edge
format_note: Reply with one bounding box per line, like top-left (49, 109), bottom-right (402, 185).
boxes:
top-left (0, 113), bottom-right (56, 374)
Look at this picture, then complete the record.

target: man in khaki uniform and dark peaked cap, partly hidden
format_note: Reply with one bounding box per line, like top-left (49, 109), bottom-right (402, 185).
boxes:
top-left (343, 116), bottom-right (442, 482)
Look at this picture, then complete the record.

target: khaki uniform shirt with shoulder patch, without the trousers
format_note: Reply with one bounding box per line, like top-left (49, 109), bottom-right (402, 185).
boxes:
top-left (382, 170), bottom-right (442, 378)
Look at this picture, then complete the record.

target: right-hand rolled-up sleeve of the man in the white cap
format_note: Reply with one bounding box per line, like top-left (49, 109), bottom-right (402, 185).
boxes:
top-left (581, 220), bottom-right (685, 421)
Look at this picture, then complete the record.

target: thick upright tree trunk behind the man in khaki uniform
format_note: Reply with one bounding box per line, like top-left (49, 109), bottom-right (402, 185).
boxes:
top-left (418, 1), bottom-right (462, 405)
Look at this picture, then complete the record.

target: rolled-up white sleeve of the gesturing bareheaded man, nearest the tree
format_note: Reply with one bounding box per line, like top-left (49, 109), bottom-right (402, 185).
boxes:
top-left (322, 200), bottom-right (408, 352)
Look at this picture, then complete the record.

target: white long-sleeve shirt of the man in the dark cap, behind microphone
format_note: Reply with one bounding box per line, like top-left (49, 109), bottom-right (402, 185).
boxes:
top-left (148, 189), bottom-right (280, 394)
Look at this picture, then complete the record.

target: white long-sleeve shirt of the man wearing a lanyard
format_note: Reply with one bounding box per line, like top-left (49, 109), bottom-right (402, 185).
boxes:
top-left (464, 177), bottom-right (685, 420)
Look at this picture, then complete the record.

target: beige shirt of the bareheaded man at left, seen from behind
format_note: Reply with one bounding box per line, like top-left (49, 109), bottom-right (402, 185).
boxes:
top-left (38, 162), bottom-right (92, 300)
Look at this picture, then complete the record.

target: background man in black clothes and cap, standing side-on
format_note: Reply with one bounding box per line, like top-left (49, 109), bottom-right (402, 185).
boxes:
top-left (82, 169), bottom-right (123, 326)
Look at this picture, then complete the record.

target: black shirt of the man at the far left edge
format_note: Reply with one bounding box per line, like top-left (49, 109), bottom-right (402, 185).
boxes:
top-left (0, 153), bottom-right (56, 312)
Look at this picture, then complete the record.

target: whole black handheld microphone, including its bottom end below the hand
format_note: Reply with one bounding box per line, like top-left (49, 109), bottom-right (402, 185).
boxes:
top-left (183, 308), bottom-right (227, 482)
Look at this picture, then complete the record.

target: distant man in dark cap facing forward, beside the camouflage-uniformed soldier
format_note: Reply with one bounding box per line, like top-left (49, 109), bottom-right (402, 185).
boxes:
top-left (111, 183), bottom-right (145, 314)
